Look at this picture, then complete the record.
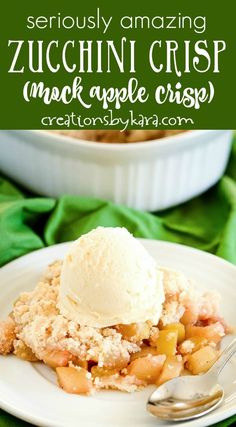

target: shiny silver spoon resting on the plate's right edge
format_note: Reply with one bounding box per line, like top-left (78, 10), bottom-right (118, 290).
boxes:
top-left (147, 338), bottom-right (236, 421)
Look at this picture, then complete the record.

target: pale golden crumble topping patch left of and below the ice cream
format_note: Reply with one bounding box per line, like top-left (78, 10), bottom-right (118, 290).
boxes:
top-left (13, 261), bottom-right (140, 366)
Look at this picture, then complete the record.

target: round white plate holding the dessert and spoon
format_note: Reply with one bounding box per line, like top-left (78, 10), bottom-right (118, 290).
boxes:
top-left (0, 240), bottom-right (236, 427)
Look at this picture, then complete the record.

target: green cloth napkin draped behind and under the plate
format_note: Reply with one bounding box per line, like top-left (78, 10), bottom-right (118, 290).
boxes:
top-left (0, 139), bottom-right (236, 427)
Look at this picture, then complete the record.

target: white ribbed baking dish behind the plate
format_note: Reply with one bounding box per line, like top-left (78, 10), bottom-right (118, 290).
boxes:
top-left (0, 130), bottom-right (232, 211)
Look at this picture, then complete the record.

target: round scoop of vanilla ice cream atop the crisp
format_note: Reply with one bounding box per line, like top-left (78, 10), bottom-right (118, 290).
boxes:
top-left (58, 227), bottom-right (164, 327)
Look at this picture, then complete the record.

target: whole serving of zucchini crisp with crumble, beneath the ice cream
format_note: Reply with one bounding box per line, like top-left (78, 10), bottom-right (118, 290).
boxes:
top-left (0, 261), bottom-right (226, 394)
